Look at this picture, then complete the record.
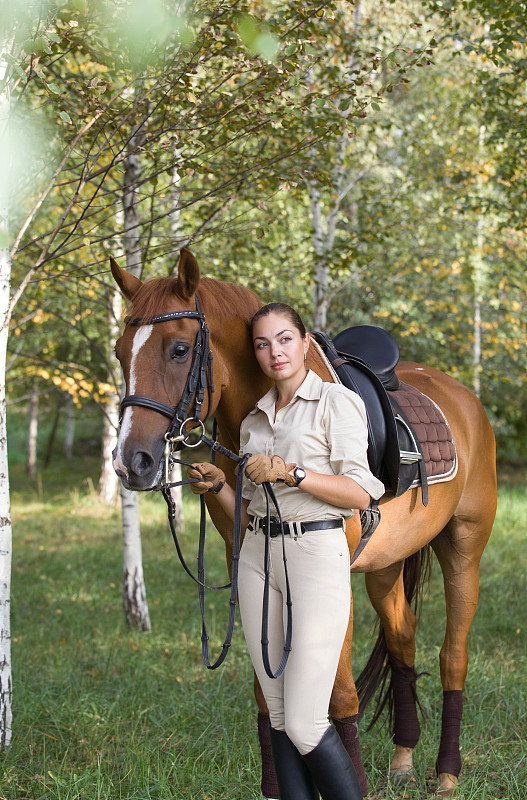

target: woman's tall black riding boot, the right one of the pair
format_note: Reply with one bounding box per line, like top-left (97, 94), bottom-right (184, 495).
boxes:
top-left (303, 726), bottom-right (362, 800)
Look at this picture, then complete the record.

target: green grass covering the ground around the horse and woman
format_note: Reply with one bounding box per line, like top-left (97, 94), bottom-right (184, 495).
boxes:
top-left (0, 458), bottom-right (527, 800)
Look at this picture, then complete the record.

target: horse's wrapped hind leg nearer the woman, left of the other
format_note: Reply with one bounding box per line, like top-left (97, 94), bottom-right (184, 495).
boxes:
top-left (365, 561), bottom-right (420, 780)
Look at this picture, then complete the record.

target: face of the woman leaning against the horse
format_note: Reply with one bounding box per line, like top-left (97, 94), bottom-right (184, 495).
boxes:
top-left (253, 312), bottom-right (309, 382)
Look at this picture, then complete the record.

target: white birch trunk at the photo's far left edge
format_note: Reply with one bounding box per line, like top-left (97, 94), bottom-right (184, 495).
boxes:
top-left (0, 48), bottom-right (13, 750)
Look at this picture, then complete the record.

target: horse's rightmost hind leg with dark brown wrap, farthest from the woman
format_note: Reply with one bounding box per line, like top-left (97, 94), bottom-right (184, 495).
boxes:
top-left (432, 509), bottom-right (494, 798)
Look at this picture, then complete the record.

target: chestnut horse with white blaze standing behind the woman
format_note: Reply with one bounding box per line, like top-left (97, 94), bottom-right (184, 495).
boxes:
top-left (112, 250), bottom-right (496, 797)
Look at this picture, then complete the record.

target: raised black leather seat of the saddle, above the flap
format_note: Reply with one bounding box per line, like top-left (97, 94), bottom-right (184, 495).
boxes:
top-left (333, 325), bottom-right (399, 391)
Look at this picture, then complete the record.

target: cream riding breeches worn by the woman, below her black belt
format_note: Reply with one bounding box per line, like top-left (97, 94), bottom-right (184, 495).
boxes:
top-left (238, 526), bottom-right (350, 755)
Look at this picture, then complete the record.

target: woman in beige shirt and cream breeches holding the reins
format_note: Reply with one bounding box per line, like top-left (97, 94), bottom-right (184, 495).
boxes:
top-left (189, 303), bottom-right (384, 800)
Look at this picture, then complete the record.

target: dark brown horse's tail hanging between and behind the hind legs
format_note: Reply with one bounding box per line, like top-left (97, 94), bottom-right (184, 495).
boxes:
top-left (355, 545), bottom-right (432, 730)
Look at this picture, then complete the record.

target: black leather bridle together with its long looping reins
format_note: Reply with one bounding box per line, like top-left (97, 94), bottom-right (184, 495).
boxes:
top-left (120, 295), bottom-right (292, 678)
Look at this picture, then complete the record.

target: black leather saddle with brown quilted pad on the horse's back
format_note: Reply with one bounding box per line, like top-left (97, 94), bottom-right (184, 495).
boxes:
top-left (312, 325), bottom-right (455, 506)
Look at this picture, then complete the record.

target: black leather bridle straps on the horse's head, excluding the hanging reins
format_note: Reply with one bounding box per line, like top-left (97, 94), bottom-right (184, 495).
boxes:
top-left (121, 295), bottom-right (214, 444)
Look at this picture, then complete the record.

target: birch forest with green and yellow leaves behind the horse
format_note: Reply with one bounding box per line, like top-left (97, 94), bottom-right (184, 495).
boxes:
top-left (0, 0), bottom-right (527, 776)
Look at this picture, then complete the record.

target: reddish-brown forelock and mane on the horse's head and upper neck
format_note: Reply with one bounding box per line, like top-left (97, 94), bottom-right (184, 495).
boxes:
top-left (126, 278), bottom-right (262, 324)
